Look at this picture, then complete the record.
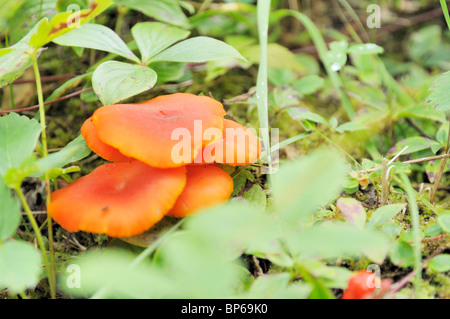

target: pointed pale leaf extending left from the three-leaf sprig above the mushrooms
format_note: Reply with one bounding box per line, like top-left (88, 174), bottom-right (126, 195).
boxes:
top-left (53, 23), bottom-right (140, 64)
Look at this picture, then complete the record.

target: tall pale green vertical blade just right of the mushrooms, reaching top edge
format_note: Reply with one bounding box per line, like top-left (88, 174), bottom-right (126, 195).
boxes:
top-left (256, 0), bottom-right (272, 175)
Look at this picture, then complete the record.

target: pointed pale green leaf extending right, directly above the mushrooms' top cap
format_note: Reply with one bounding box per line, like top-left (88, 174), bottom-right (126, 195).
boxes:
top-left (151, 36), bottom-right (244, 63)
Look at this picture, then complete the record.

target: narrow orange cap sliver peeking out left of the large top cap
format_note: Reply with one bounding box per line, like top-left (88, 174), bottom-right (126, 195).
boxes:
top-left (81, 117), bottom-right (133, 162)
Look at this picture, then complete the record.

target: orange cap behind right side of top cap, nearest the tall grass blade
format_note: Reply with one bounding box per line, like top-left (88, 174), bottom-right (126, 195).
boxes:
top-left (194, 119), bottom-right (261, 166)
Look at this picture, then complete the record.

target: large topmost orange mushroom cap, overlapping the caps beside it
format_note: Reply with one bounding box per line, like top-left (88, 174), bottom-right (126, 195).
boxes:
top-left (93, 93), bottom-right (225, 168)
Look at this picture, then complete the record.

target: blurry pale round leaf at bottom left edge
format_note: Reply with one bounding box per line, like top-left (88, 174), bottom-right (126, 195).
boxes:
top-left (0, 240), bottom-right (41, 293)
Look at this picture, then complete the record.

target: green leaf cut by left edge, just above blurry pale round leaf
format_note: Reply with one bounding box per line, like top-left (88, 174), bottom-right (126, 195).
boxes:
top-left (0, 178), bottom-right (20, 242)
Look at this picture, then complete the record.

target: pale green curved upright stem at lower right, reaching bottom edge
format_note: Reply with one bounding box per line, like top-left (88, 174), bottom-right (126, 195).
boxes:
top-left (399, 173), bottom-right (422, 298)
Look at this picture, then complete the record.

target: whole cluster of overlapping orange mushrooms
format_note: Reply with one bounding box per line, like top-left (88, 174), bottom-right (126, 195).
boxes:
top-left (48, 93), bottom-right (261, 237)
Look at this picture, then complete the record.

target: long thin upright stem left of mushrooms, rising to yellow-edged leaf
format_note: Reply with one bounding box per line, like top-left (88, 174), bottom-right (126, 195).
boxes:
top-left (31, 52), bottom-right (56, 299)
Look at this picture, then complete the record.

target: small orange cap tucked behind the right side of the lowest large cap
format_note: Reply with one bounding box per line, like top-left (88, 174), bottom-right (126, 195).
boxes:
top-left (167, 165), bottom-right (233, 217)
